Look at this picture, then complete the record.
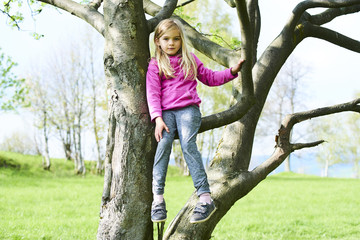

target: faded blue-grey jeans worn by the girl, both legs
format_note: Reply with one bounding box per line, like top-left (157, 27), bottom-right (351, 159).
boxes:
top-left (153, 105), bottom-right (210, 196)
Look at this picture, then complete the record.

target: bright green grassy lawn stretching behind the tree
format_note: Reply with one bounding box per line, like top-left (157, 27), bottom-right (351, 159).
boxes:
top-left (0, 152), bottom-right (360, 240)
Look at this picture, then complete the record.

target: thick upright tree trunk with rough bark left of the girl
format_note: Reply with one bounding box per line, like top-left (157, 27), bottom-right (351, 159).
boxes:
top-left (97, 0), bottom-right (155, 240)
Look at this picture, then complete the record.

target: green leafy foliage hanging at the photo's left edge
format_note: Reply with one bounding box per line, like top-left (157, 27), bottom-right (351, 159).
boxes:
top-left (0, 48), bottom-right (27, 110)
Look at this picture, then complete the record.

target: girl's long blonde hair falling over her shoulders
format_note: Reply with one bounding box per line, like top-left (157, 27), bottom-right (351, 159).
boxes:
top-left (154, 19), bottom-right (197, 80)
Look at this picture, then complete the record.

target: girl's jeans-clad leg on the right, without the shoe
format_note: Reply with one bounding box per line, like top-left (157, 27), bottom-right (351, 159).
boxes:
top-left (174, 105), bottom-right (210, 196)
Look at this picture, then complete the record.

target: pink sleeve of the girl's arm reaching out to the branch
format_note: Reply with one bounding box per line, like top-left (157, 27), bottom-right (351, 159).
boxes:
top-left (192, 54), bottom-right (238, 87)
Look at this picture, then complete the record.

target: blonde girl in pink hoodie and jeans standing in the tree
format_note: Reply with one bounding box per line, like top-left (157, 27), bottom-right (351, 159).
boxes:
top-left (146, 19), bottom-right (244, 223)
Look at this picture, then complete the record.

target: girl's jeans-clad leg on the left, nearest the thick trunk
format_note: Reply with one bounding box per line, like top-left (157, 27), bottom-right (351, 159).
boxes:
top-left (153, 110), bottom-right (176, 195)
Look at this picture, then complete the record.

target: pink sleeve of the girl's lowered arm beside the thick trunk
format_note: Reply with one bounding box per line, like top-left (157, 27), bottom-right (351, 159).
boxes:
top-left (146, 59), bottom-right (162, 121)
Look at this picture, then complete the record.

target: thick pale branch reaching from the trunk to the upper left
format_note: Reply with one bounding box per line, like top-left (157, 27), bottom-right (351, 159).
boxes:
top-left (39, 0), bottom-right (105, 36)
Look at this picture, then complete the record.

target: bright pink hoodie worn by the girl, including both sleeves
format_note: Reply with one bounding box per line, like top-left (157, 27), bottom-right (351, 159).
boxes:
top-left (146, 54), bottom-right (238, 121)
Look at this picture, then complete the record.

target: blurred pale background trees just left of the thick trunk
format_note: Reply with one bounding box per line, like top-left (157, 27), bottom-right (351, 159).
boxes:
top-left (26, 30), bottom-right (107, 167)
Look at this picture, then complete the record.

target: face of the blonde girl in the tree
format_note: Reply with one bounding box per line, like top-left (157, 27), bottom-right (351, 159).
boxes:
top-left (155, 29), bottom-right (182, 56)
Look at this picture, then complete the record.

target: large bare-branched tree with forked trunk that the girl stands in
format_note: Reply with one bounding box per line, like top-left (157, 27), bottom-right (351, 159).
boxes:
top-left (2, 0), bottom-right (360, 239)
